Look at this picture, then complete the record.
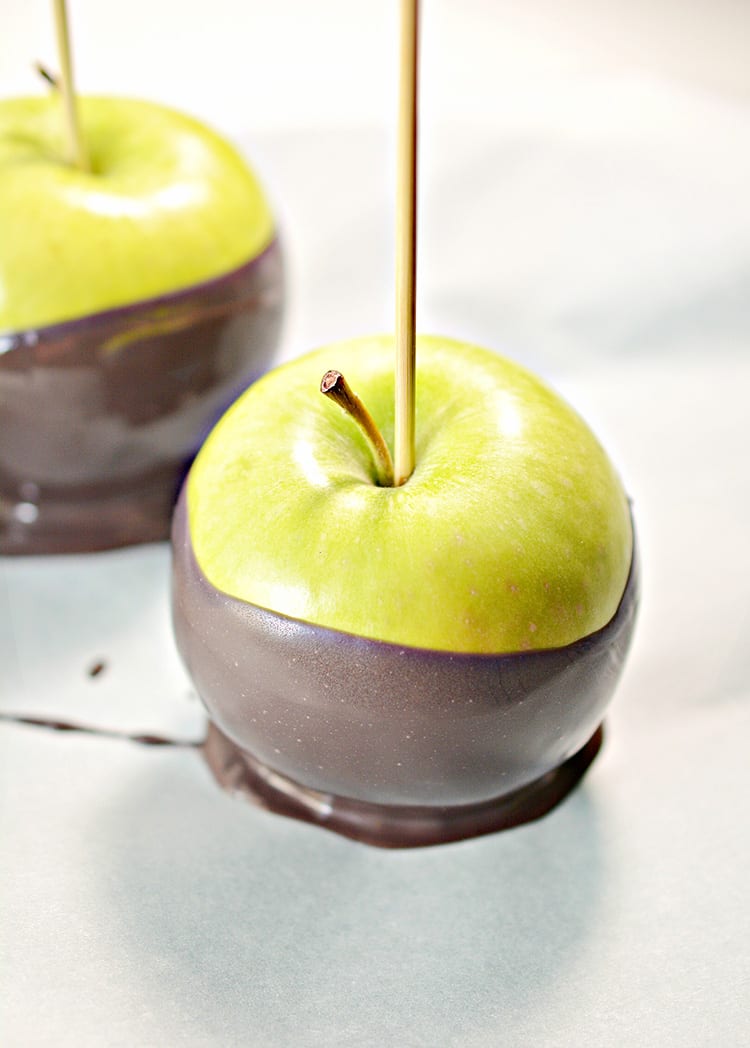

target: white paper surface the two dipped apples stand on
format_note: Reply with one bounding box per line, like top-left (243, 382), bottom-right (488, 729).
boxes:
top-left (0, 2), bottom-right (750, 1048)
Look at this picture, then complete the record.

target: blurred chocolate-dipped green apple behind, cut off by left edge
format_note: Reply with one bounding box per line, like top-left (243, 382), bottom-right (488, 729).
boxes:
top-left (0, 16), bottom-right (283, 553)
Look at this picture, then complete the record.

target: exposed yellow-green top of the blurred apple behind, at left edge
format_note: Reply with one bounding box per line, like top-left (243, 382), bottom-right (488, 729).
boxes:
top-left (0, 95), bottom-right (273, 331)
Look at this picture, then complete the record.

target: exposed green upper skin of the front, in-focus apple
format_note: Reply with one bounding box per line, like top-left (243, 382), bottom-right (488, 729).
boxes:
top-left (186, 336), bottom-right (633, 653)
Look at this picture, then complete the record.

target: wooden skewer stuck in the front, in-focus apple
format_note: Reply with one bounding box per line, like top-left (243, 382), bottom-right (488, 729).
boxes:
top-left (394, 0), bottom-right (419, 486)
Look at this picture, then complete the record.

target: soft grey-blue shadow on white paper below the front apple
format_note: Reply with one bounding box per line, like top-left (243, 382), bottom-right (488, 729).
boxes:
top-left (88, 751), bottom-right (606, 1048)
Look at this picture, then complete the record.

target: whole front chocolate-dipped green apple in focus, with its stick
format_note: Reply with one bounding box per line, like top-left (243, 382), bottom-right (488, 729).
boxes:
top-left (173, 0), bottom-right (638, 846)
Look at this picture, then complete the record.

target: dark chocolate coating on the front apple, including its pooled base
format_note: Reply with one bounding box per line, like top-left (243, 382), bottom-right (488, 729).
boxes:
top-left (173, 490), bottom-right (638, 844)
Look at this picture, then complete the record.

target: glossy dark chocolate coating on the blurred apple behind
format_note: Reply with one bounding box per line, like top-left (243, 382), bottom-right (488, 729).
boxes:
top-left (0, 240), bottom-right (283, 553)
